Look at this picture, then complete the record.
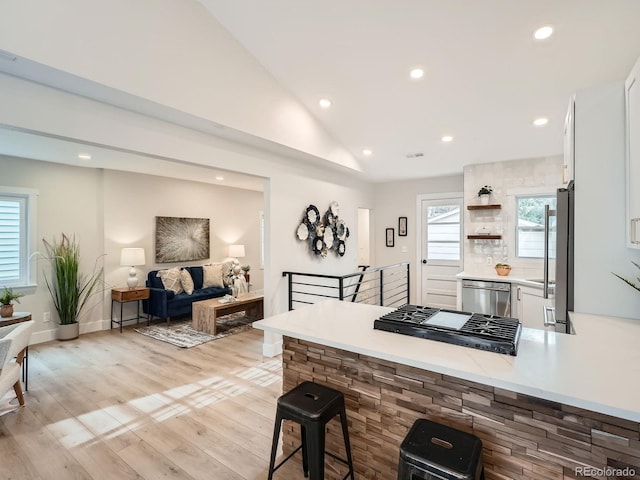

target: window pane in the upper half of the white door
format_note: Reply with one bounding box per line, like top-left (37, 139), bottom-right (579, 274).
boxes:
top-left (427, 204), bottom-right (462, 262)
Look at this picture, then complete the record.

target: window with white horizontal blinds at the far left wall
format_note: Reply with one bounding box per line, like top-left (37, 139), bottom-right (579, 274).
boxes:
top-left (0, 187), bottom-right (36, 287)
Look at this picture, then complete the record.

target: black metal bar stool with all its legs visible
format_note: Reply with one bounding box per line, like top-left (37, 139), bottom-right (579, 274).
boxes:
top-left (269, 382), bottom-right (354, 480)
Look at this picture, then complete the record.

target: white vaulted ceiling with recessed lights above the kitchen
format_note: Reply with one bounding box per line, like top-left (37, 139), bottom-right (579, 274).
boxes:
top-left (199, 0), bottom-right (640, 181)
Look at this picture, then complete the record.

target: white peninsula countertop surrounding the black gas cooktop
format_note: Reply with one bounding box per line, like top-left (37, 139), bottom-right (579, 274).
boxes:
top-left (253, 300), bottom-right (640, 422)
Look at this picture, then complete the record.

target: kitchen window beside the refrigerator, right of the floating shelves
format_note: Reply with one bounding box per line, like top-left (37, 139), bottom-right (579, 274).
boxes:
top-left (516, 195), bottom-right (556, 258)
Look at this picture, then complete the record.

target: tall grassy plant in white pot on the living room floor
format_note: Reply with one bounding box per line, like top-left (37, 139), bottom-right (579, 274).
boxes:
top-left (42, 233), bottom-right (103, 340)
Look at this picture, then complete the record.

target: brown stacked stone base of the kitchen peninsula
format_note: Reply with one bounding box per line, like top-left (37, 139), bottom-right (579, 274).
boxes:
top-left (283, 336), bottom-right (640, 480)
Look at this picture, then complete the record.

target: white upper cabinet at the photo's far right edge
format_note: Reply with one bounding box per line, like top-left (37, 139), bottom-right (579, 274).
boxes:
top-left (624, 60), bottom-right (640, 248)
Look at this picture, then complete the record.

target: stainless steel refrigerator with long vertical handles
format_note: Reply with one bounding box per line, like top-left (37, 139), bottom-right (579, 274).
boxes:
top-left (544, 181), bottom-right (575, 333)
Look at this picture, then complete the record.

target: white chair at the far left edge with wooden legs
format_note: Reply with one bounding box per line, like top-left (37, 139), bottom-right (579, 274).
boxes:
top-left (0, 320), bottom-right (34, 405)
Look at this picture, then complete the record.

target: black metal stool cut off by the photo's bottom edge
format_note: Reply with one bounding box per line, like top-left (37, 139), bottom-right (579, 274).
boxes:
top-left (398, 418), bottom-right (484, 480)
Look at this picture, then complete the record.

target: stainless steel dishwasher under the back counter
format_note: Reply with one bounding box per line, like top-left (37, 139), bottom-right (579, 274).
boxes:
top-left (462, 280), bottom-right (511, 317)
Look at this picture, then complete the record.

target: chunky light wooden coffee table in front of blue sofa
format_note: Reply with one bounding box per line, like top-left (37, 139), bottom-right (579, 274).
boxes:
top-left (191, 293), bottom-right (264, 335)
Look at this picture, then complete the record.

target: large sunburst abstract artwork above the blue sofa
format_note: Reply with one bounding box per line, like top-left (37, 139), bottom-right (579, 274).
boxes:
top-left (156, 217), bottom-right (209, 263)
